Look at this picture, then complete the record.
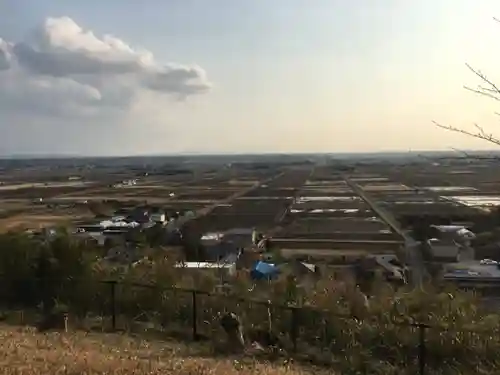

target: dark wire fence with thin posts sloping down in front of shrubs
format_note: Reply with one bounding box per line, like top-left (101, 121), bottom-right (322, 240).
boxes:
top-left (100, 281), bottom-right (499, 374)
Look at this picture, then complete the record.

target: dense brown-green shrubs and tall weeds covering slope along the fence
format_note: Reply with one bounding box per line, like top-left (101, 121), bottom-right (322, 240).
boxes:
top-left (0, 233), bottom-right (500, 374)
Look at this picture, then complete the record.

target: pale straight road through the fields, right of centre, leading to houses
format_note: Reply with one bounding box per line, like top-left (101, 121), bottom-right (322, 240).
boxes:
top-left (343, 176), bottom-right (425, 286)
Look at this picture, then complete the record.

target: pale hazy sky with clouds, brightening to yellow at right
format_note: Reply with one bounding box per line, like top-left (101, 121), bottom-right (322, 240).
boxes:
top-left (0, 0), bottom-right (500, 155)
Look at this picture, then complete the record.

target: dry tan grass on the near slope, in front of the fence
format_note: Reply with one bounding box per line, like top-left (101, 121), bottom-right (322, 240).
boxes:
top-left (0, 325), bottom-right (324, 375)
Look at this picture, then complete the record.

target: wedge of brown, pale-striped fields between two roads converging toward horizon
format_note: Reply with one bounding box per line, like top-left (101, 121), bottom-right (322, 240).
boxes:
top-left (266, 173), bottom-right (401, 256)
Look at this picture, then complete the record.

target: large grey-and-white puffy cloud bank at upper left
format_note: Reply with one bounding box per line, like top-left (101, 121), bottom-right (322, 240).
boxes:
top-left (0, 17), bottom-right (210, 117)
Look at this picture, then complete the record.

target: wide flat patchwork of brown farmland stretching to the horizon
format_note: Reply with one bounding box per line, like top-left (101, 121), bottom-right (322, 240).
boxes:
top-left (0, 153), bottom-right (500, 268)
